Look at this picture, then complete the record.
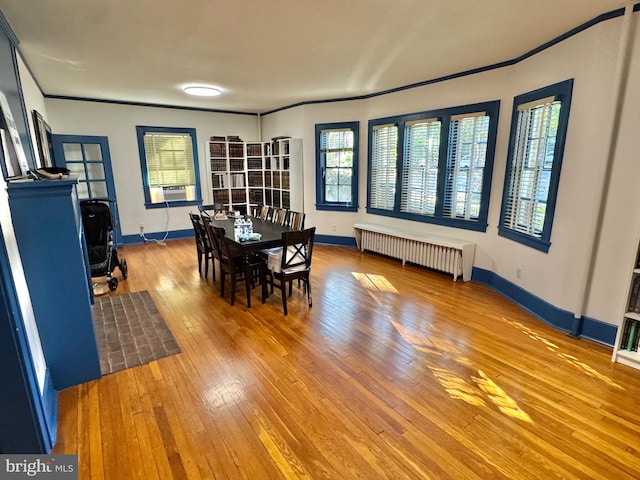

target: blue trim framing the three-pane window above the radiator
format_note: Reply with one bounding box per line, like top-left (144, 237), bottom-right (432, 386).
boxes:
top-left (367, 100), bottom-right (500, 232)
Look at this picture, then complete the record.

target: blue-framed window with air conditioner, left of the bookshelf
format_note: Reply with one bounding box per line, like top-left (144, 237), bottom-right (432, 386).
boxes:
top-left (136, 126), bottom-right (201, 208)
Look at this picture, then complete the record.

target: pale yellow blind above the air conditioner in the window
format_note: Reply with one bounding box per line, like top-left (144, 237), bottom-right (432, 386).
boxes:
top-left (144, 132), bottom-right (196, 187)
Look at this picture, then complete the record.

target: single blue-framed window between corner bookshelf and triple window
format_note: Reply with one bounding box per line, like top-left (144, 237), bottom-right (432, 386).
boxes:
top-left (316, 122), bottom-right (359, 212)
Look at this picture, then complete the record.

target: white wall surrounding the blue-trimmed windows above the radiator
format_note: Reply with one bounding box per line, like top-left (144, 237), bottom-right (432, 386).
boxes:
top-left (262, 14), bottom-right (640, 330)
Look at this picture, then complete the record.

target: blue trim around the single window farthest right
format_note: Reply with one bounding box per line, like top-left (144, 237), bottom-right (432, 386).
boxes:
top-left (498, 78), bottom-right (573, 253)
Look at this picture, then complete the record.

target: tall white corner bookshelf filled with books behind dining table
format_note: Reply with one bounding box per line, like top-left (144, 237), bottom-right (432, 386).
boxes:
top-left (208, 137), bottom-right (303, 213)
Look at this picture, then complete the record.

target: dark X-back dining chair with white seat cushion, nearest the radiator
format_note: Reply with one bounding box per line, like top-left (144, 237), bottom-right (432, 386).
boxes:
top-left (262, 227), bottom-right (316, 315)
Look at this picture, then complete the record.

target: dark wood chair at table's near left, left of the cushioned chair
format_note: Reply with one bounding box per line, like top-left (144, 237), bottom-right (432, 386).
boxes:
top-left (211, 226), bottom-right (266, 307)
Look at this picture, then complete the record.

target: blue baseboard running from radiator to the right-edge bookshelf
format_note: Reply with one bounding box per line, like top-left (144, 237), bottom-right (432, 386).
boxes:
top-left (471, 267), bottom-right (618, 346)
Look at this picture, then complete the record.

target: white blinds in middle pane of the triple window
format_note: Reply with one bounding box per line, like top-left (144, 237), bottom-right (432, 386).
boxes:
top-left (400, 118), bottom-right (442, 215)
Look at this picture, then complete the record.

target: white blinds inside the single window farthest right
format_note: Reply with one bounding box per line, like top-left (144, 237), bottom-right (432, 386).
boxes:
top-left (503, 97), bottom-right (561, 238)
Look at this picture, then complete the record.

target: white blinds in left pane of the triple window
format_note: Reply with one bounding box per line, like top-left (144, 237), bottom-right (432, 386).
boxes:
top-left (369, 125), bottom-right (398, 210)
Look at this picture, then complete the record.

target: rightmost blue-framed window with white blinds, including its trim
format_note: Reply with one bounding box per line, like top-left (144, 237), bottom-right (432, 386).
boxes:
top-left (498, 80), bottom-right (573, 252)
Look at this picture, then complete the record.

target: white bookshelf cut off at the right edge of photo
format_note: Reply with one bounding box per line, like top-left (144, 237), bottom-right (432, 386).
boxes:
top-left (612, 242), bottom-right (640, 369)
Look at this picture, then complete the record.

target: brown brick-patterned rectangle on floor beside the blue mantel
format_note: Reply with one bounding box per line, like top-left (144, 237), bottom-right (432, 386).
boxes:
top-left (93, 290), bottom-right (180, 375)
